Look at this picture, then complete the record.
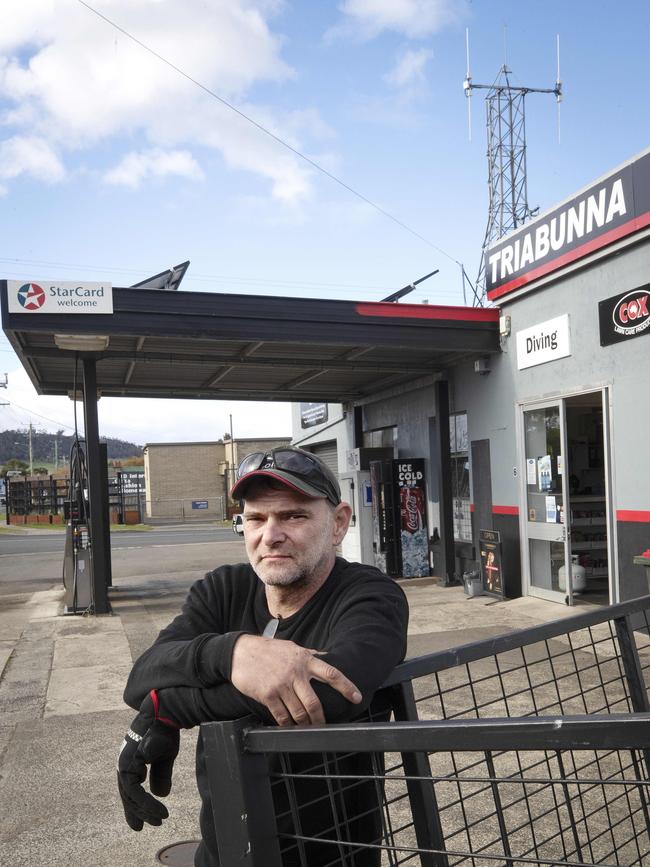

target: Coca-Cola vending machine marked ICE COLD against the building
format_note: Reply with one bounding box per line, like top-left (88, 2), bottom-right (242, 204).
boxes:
top-left (370, 458), bottom-right (431, 578)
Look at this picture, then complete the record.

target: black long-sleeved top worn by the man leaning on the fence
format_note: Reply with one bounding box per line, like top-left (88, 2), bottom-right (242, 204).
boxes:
top-left (124, 558), bottom-right (408, 867)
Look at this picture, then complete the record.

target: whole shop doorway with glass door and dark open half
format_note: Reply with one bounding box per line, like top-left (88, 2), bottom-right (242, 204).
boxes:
top-left (520, 388), bottom-right (616, 605)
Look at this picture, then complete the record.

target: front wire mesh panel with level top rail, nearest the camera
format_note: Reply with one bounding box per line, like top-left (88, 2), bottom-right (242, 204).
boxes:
top-left (240, 715), bottom-right (650, 867)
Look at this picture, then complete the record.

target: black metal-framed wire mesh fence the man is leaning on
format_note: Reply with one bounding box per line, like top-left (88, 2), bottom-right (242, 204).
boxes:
top-left (201, 597), bottom-right (650, 867)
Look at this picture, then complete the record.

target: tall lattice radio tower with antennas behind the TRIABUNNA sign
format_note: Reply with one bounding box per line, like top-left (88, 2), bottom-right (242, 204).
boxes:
top-left (463, 31), bottom-right (562, 307)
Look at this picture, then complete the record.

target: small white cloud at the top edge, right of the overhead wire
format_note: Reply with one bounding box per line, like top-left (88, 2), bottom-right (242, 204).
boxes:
top-left (332, 0), bottom-right (466, 39)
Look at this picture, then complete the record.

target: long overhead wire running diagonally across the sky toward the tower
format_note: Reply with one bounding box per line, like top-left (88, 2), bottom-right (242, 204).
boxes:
top-left (77, 0), bottom-right (463, 268)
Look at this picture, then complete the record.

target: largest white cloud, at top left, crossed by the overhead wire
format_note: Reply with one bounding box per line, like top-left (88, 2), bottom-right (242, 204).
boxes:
top-left (0, 0), bottom-right (329, 200)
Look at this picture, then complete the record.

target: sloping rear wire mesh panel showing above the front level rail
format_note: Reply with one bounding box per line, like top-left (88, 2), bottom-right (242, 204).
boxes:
top-left (390, 597), bottom-right (650, 719)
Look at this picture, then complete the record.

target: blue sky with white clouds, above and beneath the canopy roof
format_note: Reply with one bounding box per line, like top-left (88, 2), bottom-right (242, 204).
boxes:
top-left (0, 0), bottom-right (650, 443)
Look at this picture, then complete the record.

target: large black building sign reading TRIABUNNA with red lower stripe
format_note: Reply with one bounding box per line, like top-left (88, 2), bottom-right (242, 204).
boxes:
top-left (485, 152), bottom-right (650, 301)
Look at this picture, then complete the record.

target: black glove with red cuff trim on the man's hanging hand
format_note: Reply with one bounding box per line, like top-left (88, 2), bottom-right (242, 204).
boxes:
top-left (117, 689), bottom-right (179, 831)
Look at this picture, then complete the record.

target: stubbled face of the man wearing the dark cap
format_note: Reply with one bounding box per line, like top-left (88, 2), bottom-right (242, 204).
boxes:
top-left (244, 487), bottom-right (349, 587)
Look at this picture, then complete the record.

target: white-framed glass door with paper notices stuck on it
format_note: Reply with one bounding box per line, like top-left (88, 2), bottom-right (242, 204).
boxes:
top-left (522, 401), bottom-right (573, 605)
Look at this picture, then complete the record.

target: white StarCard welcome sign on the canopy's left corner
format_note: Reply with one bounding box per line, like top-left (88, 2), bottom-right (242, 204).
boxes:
top-left (7, 280), bottom-right (113, 315)
